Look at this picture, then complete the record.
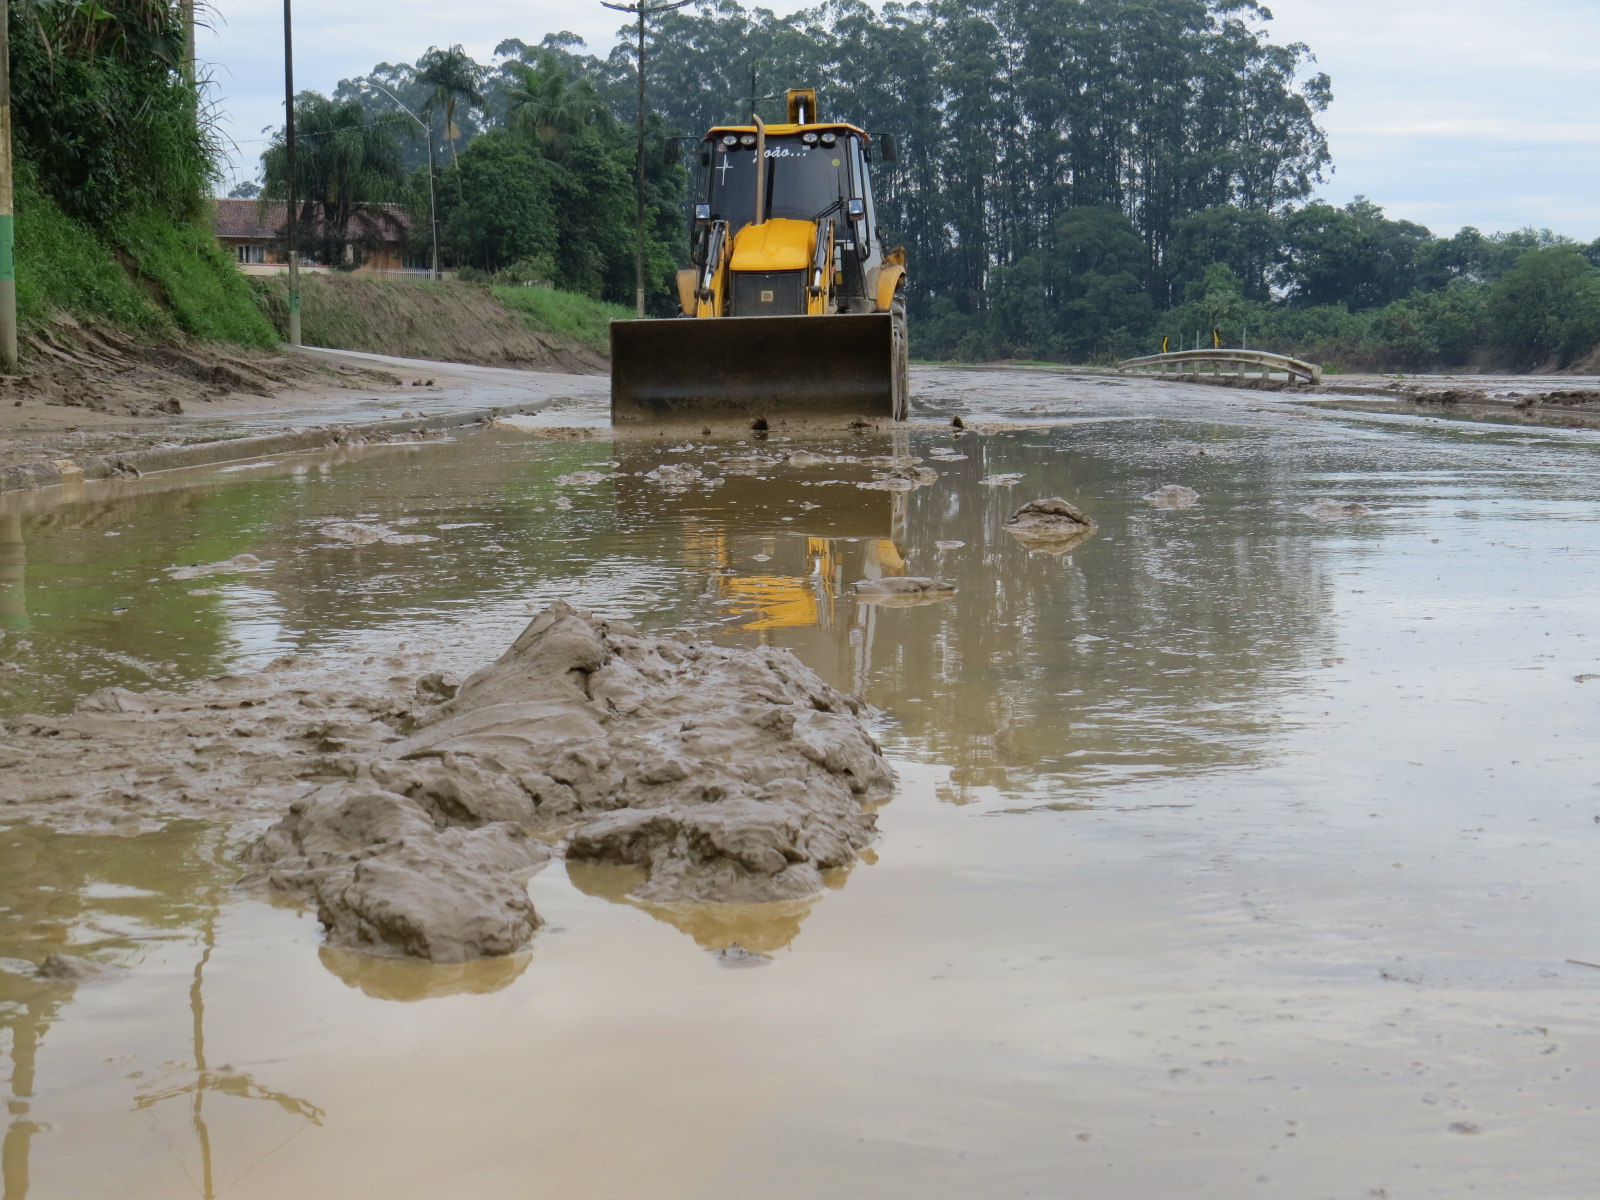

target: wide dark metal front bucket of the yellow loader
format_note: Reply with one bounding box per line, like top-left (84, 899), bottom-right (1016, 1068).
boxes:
top-left (611, 312), bottom-right (904, 426)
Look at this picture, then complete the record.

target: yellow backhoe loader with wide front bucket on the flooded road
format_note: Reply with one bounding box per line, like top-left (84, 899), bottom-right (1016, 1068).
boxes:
top-left (611, 88), bottom-right (909, 424)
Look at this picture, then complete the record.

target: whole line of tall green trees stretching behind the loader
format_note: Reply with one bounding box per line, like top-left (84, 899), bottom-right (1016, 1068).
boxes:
top-left (249, 0), bottom-right (1600, 370)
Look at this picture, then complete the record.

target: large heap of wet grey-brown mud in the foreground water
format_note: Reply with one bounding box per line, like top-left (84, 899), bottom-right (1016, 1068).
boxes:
top-left (0, 604), bottom-right (893, 962)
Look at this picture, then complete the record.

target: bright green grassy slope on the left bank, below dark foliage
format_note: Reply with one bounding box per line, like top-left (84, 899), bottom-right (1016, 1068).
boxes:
top-left (16, 184), bottom-right (278, 349)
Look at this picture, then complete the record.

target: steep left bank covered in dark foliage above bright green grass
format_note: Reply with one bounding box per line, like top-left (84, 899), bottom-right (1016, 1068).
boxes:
top-left (8, 0), bottom-right (277, 346)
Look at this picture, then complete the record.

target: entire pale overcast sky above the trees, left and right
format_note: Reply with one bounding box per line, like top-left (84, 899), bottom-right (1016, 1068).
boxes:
top-left (200, 0), bottom-right (1600, 240)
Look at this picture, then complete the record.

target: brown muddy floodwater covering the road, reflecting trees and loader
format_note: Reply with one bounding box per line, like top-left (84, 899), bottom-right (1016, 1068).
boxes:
top-left (0, 370), bottom-right (1600, 1200)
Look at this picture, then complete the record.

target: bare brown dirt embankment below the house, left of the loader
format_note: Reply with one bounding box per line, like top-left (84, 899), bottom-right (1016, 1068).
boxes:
top-left (253, 275), bottom-right (608, 374)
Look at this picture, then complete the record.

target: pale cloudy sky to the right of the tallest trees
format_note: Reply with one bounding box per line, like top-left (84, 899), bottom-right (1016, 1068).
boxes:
top-left (1269, 0), bottom-right (1600, 240)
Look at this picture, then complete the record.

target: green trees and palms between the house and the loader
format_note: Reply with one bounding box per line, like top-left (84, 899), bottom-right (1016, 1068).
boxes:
top-left (291, 37), bottom-right (686, 314)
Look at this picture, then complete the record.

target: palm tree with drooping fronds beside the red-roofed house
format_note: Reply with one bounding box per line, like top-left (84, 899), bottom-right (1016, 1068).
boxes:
top-left (261, 91), bottom-right (406, 266)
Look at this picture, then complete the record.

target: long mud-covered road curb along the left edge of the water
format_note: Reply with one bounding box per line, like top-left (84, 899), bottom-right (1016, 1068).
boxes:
top-left (0, 400), bottom-right (550, 494)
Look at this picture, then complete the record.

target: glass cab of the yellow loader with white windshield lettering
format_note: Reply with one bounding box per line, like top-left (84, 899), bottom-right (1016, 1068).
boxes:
top-left (694, 123), bottom-right (882, 315)
